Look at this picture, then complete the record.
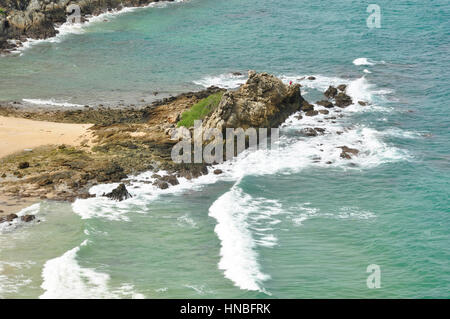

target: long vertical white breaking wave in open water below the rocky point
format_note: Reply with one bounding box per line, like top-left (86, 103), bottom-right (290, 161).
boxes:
top-left (209, 183), bottom-right (282, 293)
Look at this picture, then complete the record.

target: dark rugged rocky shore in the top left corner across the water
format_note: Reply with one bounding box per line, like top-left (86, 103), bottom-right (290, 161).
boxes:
top-left (0, 0), bottom-right (174, 52)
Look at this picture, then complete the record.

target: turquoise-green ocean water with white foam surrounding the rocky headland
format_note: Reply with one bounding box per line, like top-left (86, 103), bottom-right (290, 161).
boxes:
top-left (0, 0), bottom-right (450, 298)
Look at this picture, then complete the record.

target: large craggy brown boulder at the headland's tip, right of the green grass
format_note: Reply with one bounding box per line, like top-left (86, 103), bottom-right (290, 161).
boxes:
top-left (203, 71), bottom-right (304, 131)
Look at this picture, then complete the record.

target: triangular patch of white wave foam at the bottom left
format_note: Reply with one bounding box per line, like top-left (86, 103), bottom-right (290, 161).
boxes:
top-left (40, 240), bottom-right (144, 299)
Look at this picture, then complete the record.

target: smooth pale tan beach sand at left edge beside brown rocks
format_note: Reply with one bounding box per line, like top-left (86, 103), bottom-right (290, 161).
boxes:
top-left (0, 116), bottom-right (92, 216)
